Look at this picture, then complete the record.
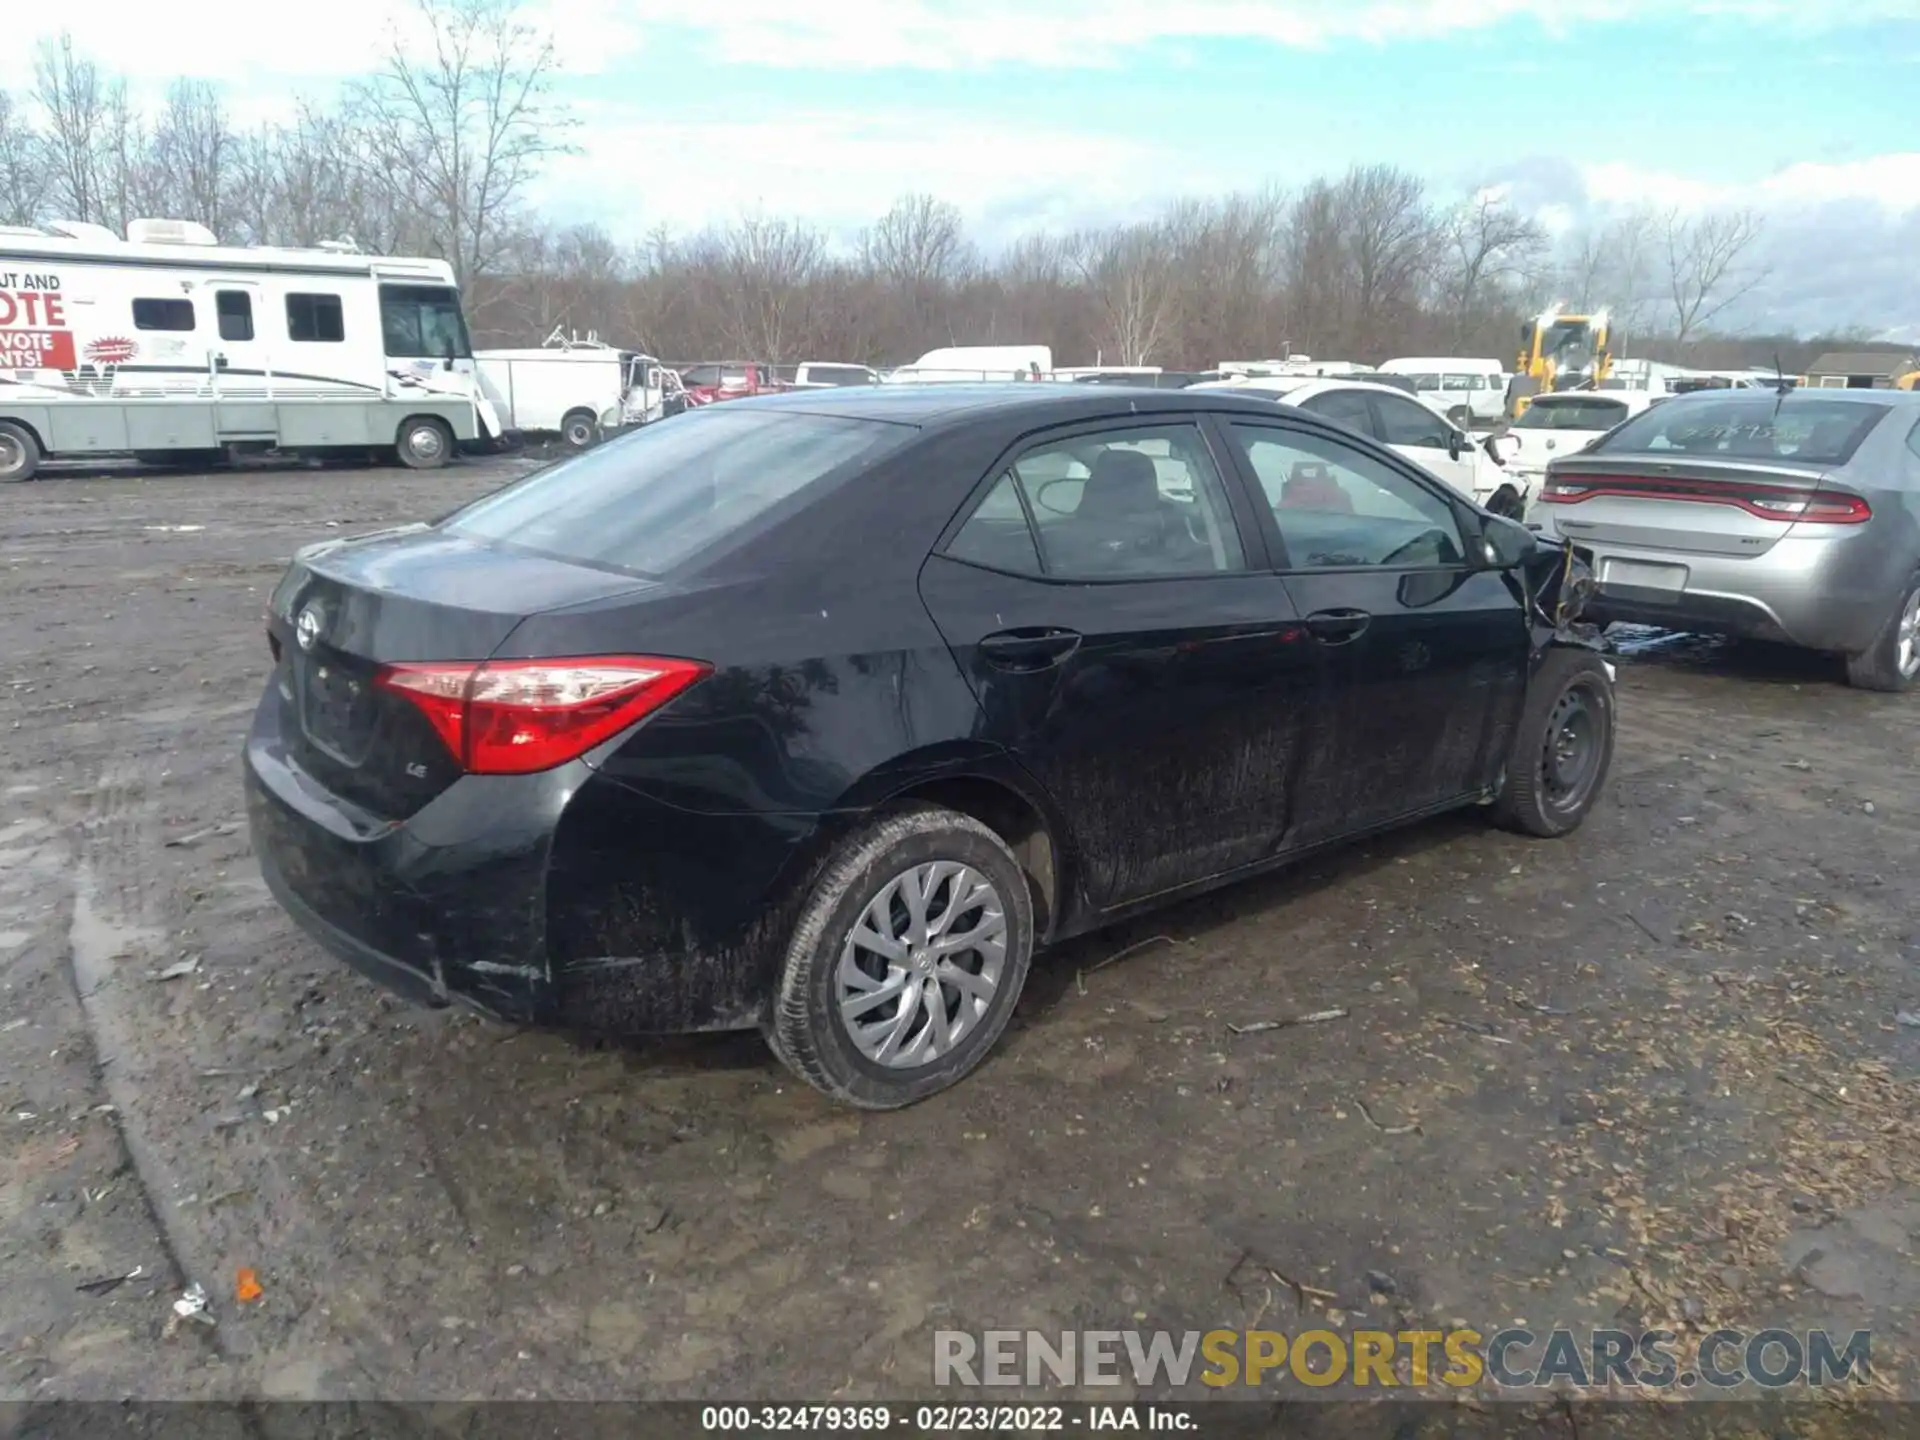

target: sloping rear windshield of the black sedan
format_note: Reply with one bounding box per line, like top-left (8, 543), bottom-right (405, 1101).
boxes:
top-left (445, 403), bottom-right (918, 576)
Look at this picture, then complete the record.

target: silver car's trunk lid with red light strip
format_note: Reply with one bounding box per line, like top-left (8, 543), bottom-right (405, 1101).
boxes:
top-left (1542, 453), bottom-right (1851, 557)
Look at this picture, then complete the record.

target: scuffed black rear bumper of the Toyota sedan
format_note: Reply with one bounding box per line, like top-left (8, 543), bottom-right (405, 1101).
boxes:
top-left (242, 691), bottom-right (814, 1035)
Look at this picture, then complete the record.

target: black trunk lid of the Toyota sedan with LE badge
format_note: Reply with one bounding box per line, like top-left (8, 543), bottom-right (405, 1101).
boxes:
top-left (267, 526), bottom-right (651, 820)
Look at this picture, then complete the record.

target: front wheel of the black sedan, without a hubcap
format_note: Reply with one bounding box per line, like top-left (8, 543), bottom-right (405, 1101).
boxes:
top-left (1494, 649), bottom-right (1613, 839)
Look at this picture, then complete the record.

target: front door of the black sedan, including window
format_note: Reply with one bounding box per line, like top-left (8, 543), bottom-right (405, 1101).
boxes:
top-left (1225, 419), bottom-right (1526, 847)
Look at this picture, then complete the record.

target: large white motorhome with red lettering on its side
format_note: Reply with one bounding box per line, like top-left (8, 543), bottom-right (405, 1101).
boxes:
top-left (0, 221), bottom-right (501, 480)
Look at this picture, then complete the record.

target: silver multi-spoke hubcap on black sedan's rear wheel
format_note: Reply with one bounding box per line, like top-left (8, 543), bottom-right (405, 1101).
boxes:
top-left (833, 860), bottom-right (1006, 1069)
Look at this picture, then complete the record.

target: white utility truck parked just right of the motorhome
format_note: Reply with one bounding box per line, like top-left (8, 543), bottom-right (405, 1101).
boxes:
top-left (474, 330), bottom-right (685, 449)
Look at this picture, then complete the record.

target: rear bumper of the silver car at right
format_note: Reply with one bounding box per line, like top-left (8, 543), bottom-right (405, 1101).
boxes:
top-left (1528, 526), bottom-right (1893, 655)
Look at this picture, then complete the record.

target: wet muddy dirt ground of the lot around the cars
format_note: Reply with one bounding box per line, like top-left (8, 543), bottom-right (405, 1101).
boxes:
top-left (0, 463), bottom-right (1920, 1398)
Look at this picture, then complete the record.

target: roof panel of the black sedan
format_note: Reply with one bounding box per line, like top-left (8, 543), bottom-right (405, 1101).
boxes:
top-left (726, 380), bottom-right (1297, 424)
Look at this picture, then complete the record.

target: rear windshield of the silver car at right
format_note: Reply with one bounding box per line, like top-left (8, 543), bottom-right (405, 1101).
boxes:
top-left (1588, 392), bottom-right (1887, 465)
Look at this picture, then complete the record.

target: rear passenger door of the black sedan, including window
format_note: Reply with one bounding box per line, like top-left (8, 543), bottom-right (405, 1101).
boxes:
top-left (920, 419), bottom-right (1319, 908)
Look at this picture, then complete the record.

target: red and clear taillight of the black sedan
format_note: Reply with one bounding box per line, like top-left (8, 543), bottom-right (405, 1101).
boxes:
top-left (378, 655), bottom-right (712, 776)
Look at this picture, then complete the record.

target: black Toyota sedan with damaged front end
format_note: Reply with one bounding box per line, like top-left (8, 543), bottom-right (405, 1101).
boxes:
top-left (244, 386), bottom-right (1613, 1108)
